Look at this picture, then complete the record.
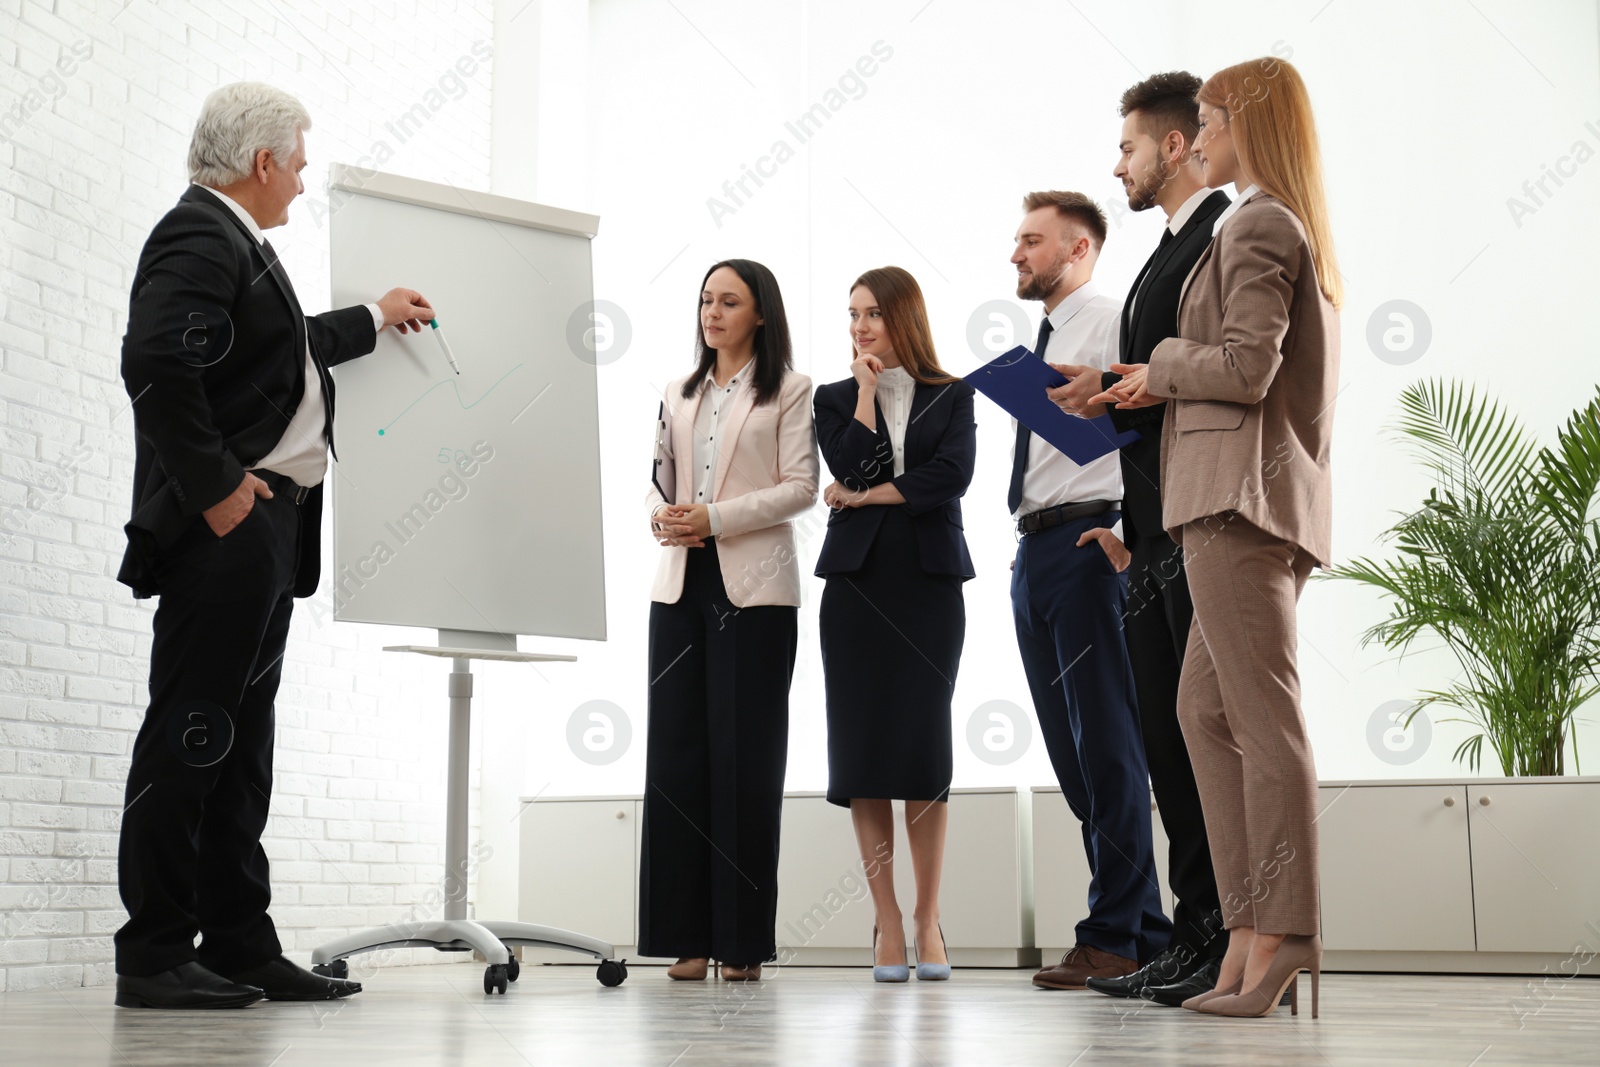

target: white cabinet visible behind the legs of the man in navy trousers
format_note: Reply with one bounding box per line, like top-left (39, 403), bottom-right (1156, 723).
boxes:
top-left (1032, 785), bottom-right (1173, 963)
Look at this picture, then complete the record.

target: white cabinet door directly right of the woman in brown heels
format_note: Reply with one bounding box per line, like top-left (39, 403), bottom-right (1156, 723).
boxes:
top-left (1317, 784), bottom-right (1474, 952)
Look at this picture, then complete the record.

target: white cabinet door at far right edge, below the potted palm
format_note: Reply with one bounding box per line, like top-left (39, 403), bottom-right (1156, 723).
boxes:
top-left (1467, 782), bottom-right (1600, 953)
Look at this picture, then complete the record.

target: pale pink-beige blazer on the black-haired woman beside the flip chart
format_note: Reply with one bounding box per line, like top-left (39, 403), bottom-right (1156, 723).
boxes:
top-left (645, 371), bottom-right (818, 608)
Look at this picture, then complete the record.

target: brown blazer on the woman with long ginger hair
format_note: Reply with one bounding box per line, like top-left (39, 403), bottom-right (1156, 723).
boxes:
top-left (1147, 192), bottom-right (1339, 566)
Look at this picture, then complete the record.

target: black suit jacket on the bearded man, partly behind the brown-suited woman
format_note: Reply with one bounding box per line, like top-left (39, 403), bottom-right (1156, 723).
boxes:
top-left (1102, 189), bottom-right (1229, 544)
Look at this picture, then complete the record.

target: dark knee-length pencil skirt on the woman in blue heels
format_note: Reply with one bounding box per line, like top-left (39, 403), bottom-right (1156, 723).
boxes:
top-left (819, 507), bottom-right (966, 808)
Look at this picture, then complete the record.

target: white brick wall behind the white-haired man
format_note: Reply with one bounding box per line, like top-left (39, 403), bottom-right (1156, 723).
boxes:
top-left (0, 0), bottom-right (493, 990)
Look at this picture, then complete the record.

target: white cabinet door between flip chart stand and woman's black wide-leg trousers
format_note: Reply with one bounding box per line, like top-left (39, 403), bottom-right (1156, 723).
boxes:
top-left (517, 800), bottom-right (638, 945)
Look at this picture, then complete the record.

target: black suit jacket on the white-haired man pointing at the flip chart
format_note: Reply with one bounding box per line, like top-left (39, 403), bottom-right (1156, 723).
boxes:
top-left (117, 186), bottom-right (378, 597)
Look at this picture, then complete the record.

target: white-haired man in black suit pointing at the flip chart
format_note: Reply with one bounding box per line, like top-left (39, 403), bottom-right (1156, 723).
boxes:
top-left (115, 82), bottom-right (434, 1008)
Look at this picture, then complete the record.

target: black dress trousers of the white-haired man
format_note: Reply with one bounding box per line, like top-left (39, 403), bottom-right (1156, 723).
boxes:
top-left (115, 488), bottom-right (300, 977)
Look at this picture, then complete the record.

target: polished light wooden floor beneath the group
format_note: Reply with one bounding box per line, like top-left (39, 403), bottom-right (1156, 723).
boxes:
top-left (0, 963), bottom-right (1600, 1067)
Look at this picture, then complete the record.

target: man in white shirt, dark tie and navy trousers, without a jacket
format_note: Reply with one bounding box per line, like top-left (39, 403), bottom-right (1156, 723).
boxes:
top-left (1008, 192), bottom-right (1171, 989)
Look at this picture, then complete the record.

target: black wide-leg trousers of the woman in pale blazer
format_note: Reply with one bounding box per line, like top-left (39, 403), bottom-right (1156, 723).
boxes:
top-left (638, 537), bottom-right (798, 965)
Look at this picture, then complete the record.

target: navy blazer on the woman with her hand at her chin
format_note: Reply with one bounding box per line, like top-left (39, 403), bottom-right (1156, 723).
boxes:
top-left (811, 378), bottom-right (978, 581)
